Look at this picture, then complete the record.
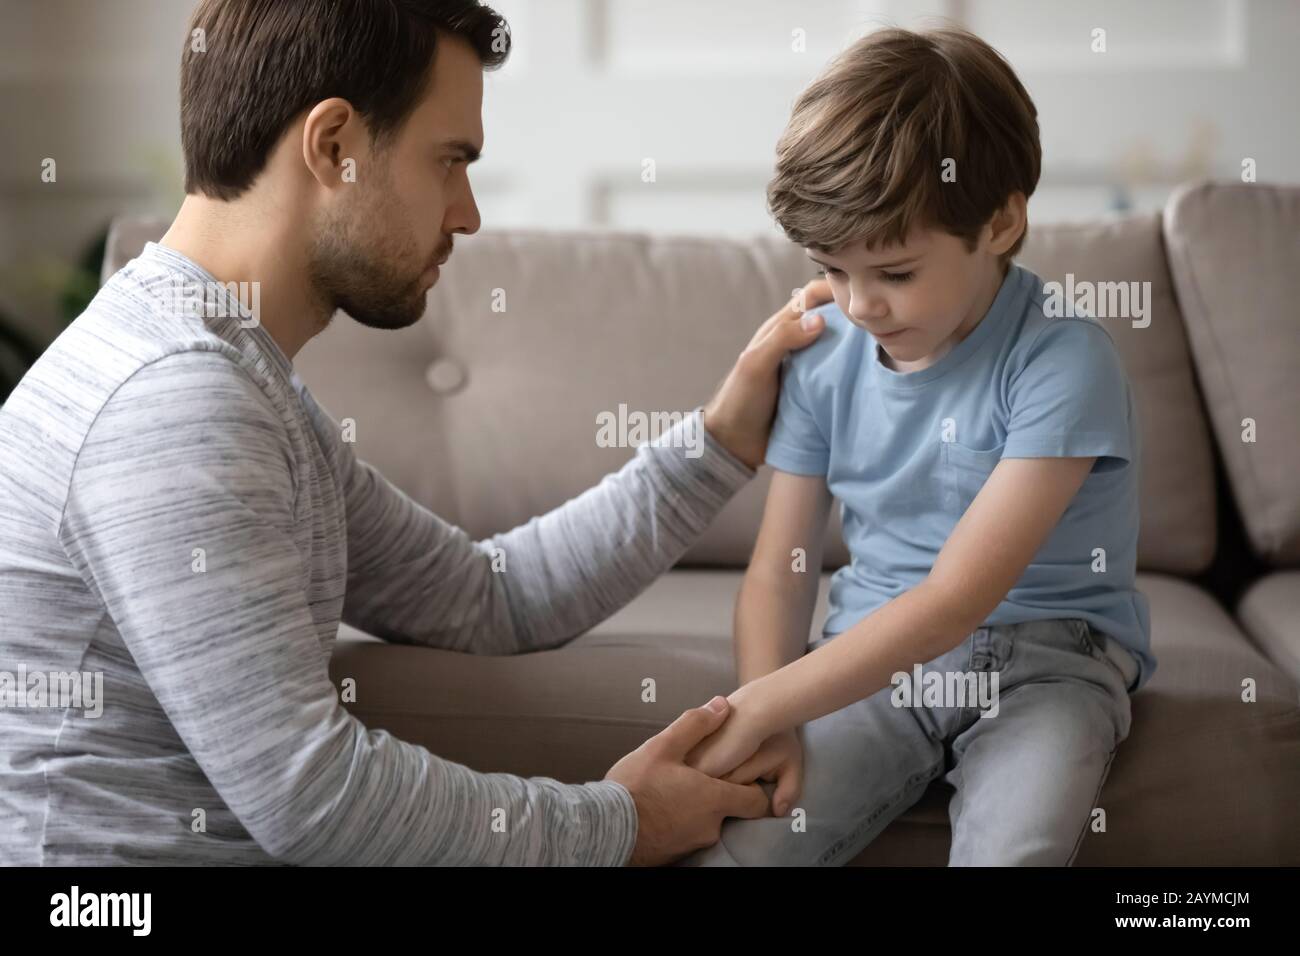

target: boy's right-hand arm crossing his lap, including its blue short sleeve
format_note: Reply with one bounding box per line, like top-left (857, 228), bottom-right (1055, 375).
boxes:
top-left (724, 310), bottom-right (1138, 749)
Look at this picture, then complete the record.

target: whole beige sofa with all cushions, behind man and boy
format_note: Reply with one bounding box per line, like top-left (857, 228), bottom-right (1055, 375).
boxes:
top-left (104, 183), bottom-right (1300, 865)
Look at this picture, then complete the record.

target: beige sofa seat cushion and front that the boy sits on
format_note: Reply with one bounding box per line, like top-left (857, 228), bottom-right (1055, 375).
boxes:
top-left (330, 571), bottom-right (1300, 866)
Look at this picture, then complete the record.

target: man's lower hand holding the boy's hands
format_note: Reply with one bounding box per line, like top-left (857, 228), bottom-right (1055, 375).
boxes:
top-left (605, 697), bottom-right (768, 866)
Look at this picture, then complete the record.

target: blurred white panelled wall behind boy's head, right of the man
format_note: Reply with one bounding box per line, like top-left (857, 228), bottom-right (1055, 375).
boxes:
top-left (481, 0), bottom-right (1300, 233)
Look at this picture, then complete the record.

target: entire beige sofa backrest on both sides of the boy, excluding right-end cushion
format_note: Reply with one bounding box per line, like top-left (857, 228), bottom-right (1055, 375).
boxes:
top-left (104, 216), bottom-right (1216, 574)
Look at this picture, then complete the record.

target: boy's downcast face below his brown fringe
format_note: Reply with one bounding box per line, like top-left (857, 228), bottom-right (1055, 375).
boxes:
top-left (805, 229), bottom-right (1002, 369)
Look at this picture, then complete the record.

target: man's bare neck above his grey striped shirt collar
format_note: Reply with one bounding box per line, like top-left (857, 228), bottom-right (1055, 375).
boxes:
top-left (159, 195), bottom-right (330, 362)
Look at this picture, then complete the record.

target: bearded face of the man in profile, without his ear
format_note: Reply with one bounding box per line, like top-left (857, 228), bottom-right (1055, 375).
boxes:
top-left (308, 36), bottom-right (484, 329)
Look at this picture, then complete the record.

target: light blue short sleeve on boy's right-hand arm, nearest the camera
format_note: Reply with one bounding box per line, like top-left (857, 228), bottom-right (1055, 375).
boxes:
top-left (1002, 319), bottom-right (1134, 471)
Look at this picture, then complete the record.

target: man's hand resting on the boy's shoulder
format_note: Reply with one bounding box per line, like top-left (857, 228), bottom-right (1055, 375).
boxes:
top-left (703, 278), bottom-right (832, 468)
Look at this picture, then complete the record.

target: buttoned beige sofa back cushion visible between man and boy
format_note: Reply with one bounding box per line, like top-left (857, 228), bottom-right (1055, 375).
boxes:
top-left (295, 230), bottom-right (848, 567)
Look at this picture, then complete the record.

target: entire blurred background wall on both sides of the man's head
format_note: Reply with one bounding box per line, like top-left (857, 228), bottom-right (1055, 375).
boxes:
top-left (0, 0), bottom-right (1300, 332)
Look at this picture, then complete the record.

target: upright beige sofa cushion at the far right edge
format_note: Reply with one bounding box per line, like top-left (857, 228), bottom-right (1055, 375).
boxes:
top-left (1165, 183), bottom-right (1300, 564)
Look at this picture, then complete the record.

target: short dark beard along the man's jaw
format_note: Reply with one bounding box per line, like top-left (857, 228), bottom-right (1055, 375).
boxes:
top-left (308, 191), bottom-right (439, 329)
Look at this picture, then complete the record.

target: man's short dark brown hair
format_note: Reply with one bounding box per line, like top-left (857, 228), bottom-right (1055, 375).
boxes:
top-left (181, 0), bottom-right (510, 200)
